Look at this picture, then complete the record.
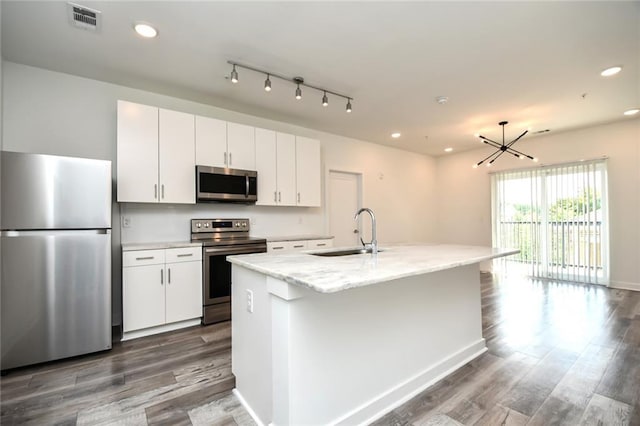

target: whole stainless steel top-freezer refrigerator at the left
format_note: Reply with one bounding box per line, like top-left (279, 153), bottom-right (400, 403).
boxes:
top-left (0, 151), bottom-right (111, 371)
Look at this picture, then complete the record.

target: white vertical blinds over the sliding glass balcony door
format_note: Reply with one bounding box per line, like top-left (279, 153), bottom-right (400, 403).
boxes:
top-left (491, 160), bottom-right (609, 284)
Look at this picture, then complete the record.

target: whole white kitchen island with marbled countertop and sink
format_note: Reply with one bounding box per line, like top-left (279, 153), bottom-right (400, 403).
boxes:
top-left (228, 244), bottom-right (517, 426)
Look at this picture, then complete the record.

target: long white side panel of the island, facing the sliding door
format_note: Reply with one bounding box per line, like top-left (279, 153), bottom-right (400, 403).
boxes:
top-left (272, 264), bottom-right (486, 425)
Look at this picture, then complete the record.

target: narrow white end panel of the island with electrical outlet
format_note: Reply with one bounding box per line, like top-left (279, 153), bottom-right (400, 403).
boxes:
top-left (231, 265), bottom-right (272, 424)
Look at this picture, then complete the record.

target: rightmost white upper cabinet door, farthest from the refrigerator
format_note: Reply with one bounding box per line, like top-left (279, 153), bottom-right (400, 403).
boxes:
top-left (296, 136), bottom-right (322, 207)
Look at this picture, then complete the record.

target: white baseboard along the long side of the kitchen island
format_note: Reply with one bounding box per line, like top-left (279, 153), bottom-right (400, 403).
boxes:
top-left (331, 339), bottom-right (487, 426)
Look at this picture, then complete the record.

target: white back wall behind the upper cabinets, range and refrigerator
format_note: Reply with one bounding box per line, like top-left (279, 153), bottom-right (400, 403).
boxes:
top-left (2, 62), bottom-right (436, 324)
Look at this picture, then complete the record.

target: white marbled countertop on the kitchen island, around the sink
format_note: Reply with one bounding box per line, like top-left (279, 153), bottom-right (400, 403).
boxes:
top-left (227, 244), bottom-right (519, 293)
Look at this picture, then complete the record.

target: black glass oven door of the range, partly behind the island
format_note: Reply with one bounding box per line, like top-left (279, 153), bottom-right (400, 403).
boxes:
top-left (202, 244), bottom-right (267, 306)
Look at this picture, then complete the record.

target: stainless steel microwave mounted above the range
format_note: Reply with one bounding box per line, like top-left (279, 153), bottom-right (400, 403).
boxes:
top-left (196, 166), bottom-right (258, 204)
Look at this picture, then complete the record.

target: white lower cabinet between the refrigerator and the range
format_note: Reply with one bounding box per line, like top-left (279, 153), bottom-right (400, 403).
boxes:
top-left (122, 247), bottom-right (202, 335)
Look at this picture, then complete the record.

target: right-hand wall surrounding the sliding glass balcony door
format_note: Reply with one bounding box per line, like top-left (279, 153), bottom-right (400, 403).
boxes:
top-left (436, 119), bottom-right (640, 289)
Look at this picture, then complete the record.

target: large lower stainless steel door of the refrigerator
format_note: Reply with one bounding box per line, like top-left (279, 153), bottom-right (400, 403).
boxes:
top-left (0, 230), bottom-right (111, 370)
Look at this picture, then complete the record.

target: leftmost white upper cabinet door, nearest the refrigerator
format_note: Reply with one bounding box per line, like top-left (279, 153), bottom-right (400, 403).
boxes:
top-left (116, 101), bottom-right (159, 203)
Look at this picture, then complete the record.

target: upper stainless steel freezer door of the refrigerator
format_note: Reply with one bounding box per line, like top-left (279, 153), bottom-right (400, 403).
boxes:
top-left (0, 151), bottom-right (111, 230)
